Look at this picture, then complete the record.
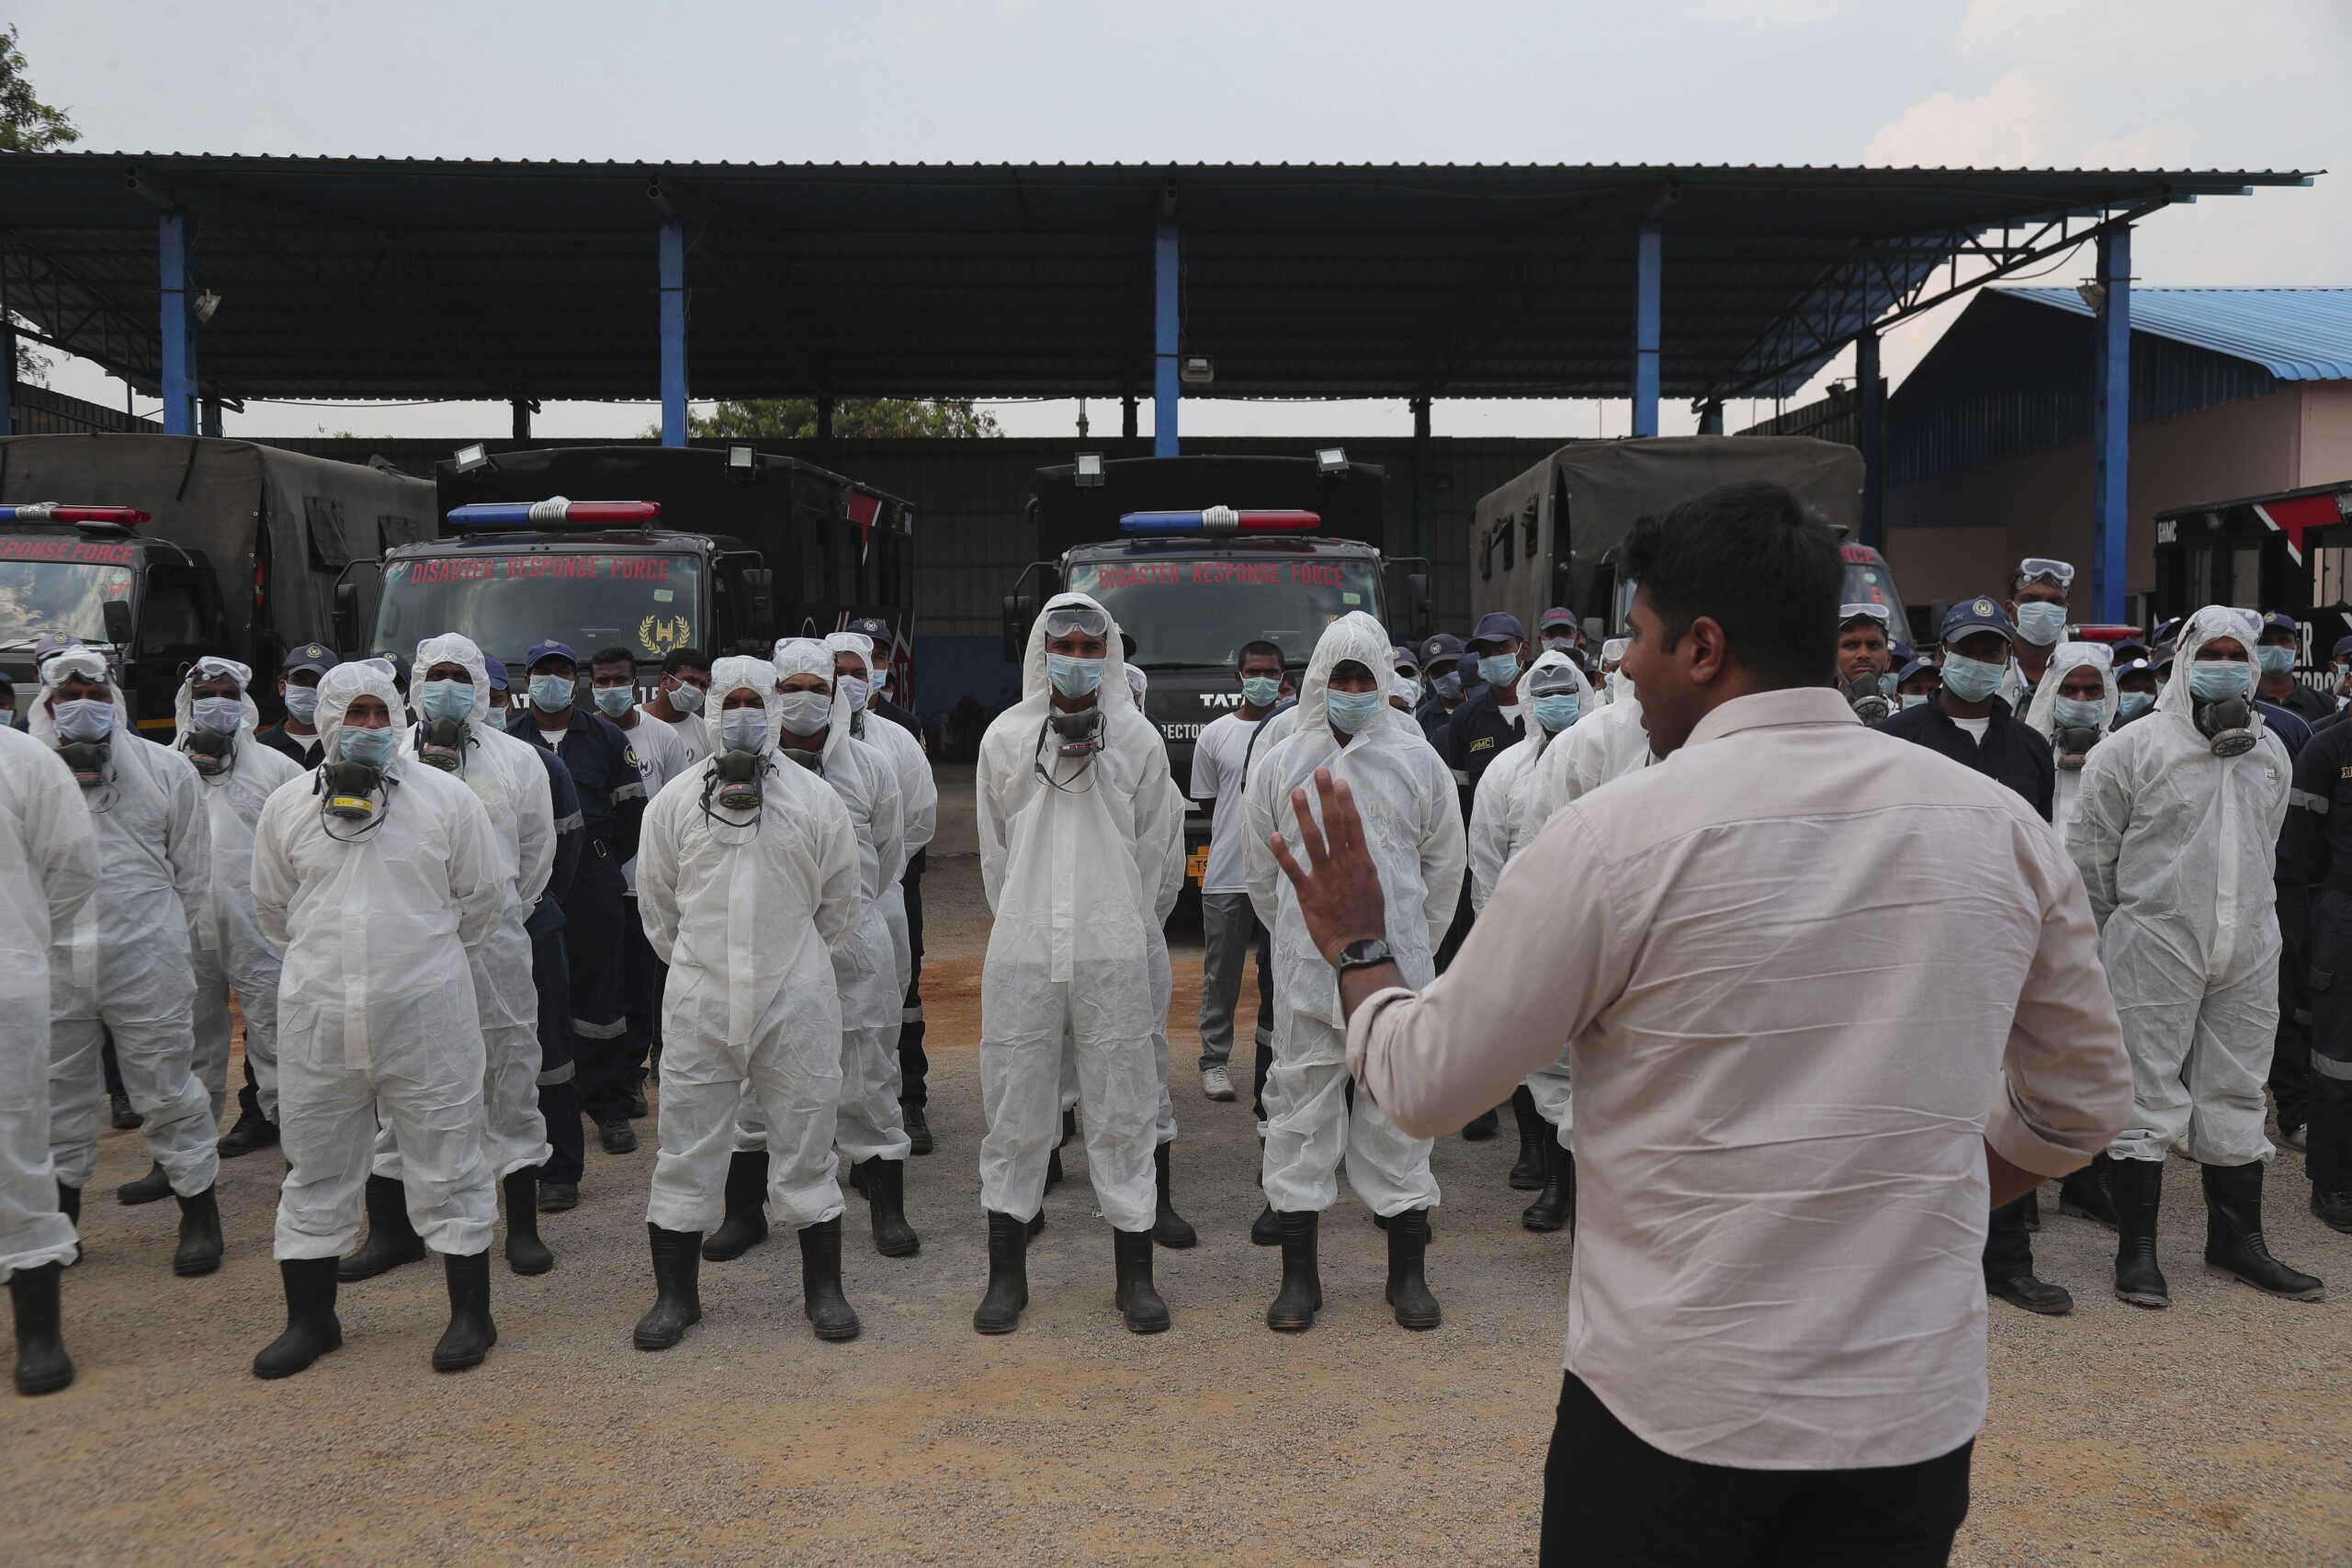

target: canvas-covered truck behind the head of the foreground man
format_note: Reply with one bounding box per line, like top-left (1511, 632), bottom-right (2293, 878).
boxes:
top-left (1470, 434), bottom-right (1933, 639)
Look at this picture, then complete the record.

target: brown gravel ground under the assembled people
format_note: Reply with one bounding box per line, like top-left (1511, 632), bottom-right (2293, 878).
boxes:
top-left (0, 856), bottom-right (2352, 1565)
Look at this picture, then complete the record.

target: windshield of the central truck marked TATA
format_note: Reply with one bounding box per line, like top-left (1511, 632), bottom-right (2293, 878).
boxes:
top-left (1070, 555), bottom-right (1381, 670)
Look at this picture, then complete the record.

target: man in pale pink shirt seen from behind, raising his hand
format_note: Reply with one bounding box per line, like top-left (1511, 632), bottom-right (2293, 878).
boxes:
top-left (1275, 484), bottom-right (2131, 1568)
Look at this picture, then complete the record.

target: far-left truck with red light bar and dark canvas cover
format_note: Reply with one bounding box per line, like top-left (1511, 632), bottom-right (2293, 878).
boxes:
top-left (0, 433), bottom-right (433, 739)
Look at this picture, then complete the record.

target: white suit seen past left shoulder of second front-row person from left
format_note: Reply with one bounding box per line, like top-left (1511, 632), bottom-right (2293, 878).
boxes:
top-left (172, 659), bottom-right (301, 1122)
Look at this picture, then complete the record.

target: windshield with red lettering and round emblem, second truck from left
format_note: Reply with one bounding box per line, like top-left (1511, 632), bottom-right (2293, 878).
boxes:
top-left (374, 550), bottom-right (703, 677)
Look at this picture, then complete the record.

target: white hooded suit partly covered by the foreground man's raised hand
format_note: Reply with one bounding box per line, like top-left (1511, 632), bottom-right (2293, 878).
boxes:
top-left (1244, 611), bottom-right (1465, 1218)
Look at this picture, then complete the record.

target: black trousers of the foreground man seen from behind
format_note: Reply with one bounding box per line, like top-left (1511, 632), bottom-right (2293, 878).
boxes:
top-left (1538, 1373), bottom-right (1975, 1568)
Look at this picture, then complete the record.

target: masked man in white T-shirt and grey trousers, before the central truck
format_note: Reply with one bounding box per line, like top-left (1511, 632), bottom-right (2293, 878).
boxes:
top-left (1193, 642), bottom-right (1282, 1100)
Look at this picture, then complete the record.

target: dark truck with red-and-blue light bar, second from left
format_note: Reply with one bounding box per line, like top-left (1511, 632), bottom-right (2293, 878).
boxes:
top-left (367, 446), bottom-right (915, 691)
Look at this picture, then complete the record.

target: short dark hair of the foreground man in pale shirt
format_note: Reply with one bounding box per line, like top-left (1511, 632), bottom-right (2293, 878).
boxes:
top-left (1623, 484), bottom-right (1847, 686)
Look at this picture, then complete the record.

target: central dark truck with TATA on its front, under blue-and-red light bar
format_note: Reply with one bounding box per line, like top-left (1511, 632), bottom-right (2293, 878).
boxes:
top-left (1004, 446), bottom-right (1430, 886)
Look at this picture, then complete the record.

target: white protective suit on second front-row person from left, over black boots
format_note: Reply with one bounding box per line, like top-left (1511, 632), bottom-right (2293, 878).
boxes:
top-left (254, 660), bottom-right (513, 1260)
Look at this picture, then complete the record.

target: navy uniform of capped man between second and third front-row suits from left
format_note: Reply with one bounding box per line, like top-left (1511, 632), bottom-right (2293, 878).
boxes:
top-left (505, 707), bottom-right (644, 1126)
